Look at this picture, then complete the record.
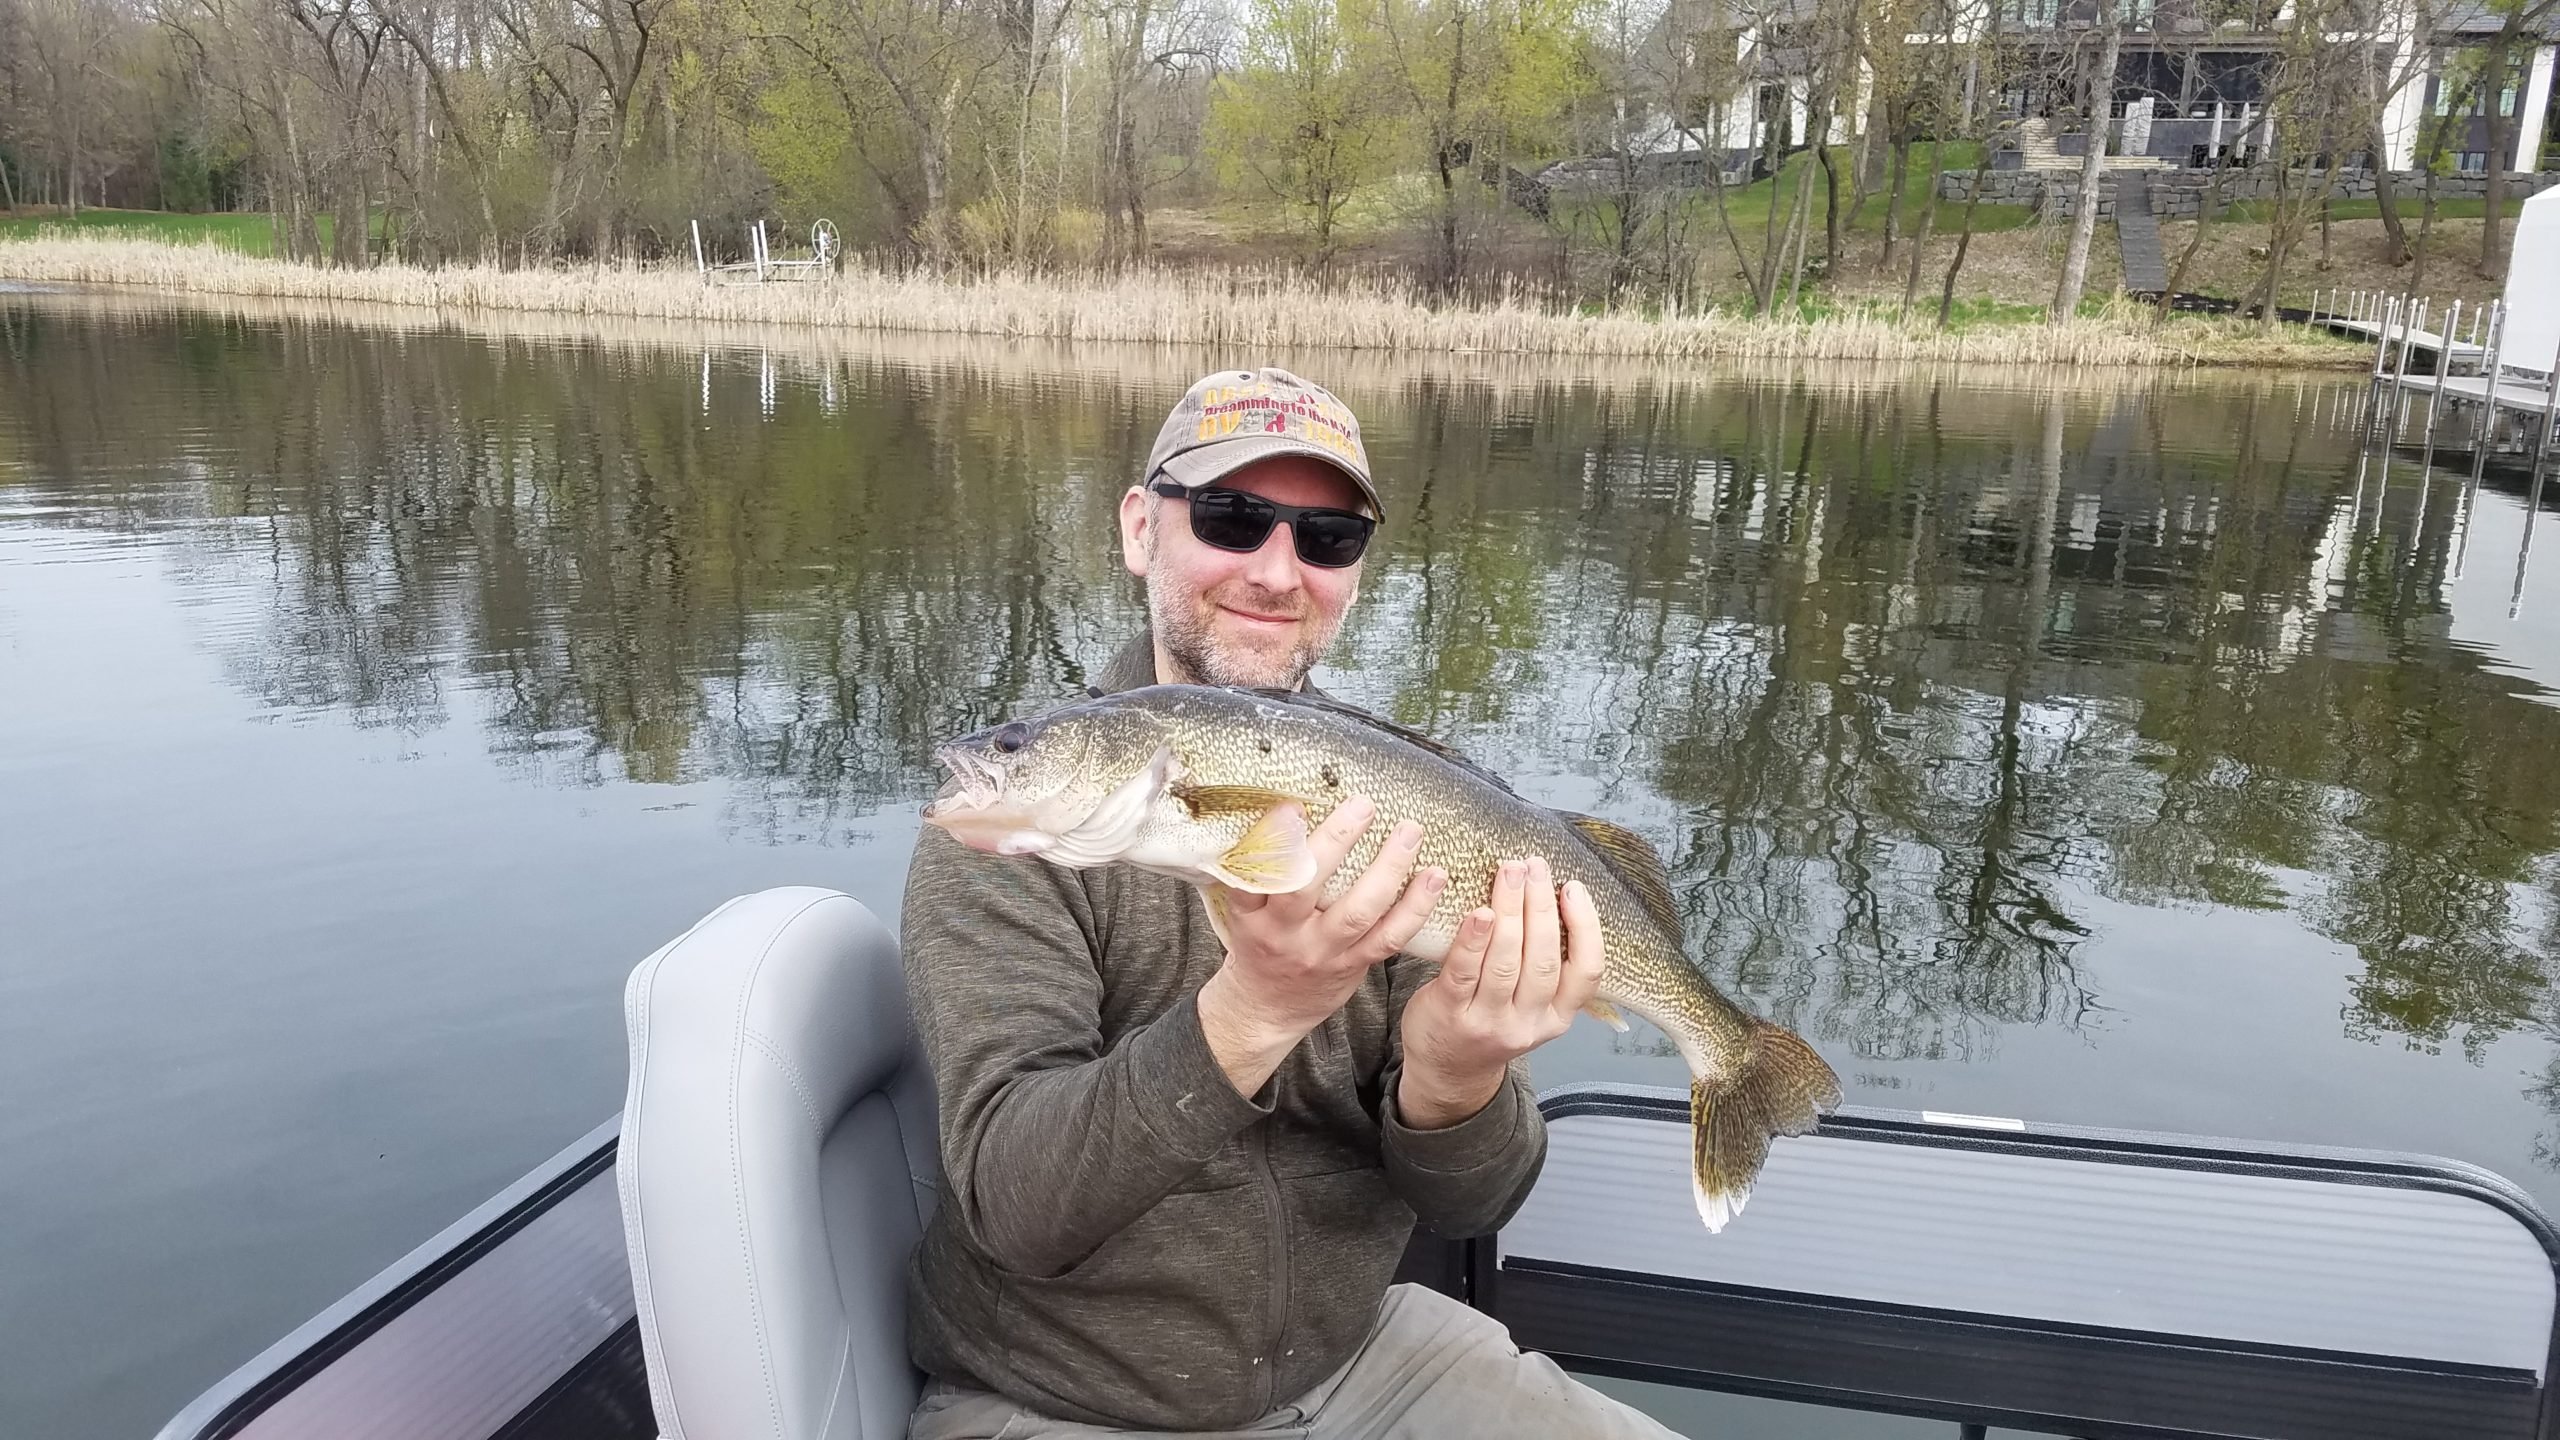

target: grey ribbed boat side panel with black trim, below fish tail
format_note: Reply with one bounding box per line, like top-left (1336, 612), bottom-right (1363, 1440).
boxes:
top-left (1485, 1086), bottom-right (2560, 1440)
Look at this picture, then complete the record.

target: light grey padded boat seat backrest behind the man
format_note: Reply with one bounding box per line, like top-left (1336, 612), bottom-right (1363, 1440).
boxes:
top-left (617, 887), bottom-right (940, 1440)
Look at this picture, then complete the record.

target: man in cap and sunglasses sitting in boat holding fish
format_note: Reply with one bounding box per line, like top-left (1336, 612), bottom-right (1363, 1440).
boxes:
top-left (904, 369), bottom-right (1669, 1440)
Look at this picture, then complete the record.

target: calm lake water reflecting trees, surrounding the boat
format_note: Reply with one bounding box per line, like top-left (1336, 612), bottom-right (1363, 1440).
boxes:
top-left (0, 295), bottom-right (2560, 1437)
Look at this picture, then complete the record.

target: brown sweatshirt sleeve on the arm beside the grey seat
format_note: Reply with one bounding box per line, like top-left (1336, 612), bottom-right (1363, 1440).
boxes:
top-left (899, 828), bottom-right (1272, 1276)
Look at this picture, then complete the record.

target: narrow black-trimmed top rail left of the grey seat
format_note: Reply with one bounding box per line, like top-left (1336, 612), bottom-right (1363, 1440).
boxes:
top-left (156, 1115), bottom-right (622, 1440)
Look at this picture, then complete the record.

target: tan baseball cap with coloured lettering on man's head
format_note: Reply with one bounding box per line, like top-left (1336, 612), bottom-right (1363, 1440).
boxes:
top-left (1139, 366), bottom-right (1388, 515)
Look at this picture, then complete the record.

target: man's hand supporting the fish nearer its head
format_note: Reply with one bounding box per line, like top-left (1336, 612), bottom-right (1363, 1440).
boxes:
top-left (1201, 794), bottom-right (1449, 1094)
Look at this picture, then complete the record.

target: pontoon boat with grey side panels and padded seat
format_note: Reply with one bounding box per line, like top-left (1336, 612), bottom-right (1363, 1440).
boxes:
top-left (161, 887), bottom-right (2560, 1440)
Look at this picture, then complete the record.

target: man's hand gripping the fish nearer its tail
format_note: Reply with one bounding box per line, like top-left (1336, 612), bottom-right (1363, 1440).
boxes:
top-left (1395, 858), bottom-right (1605, 1130)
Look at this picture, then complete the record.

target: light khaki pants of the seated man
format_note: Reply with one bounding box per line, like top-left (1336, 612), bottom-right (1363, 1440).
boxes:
top-left (906, 1286), bottom-right (1677, 1440)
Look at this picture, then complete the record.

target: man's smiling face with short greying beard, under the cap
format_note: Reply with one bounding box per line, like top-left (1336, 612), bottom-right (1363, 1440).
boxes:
top-left (1121, 456), bottom-right (1364, 689)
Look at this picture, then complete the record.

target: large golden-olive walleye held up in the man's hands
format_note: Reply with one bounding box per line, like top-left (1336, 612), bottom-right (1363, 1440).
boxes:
top-left (924, 684), bottom-right (1841, 1230)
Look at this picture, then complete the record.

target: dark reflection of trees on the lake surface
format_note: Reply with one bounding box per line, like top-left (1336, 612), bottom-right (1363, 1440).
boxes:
top-left (0, 302), bottom-right (2560, 1061)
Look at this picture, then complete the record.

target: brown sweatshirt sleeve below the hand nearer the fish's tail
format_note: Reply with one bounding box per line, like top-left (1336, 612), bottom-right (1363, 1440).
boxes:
top-left (1377, 956), bottom-right (1546, 1240)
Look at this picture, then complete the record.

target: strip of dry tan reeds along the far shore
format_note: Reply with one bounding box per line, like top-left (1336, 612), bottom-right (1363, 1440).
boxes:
top-left (0, 236), bottom-right (2368, 372)
